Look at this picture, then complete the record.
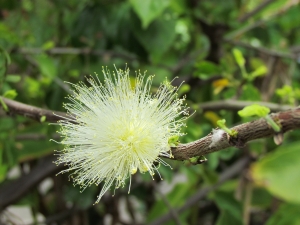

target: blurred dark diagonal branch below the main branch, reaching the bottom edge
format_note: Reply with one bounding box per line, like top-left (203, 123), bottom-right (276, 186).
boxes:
top-left (149, 157), bottom-right (250, 225)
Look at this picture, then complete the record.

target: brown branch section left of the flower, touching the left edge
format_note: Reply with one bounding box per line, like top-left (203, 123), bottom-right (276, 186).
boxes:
top-left (0, 97), bottom-right (68, 122)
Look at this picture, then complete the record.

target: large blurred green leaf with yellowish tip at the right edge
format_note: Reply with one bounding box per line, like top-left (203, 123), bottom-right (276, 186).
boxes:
top-left (251, 141), bottom-right (300, 203)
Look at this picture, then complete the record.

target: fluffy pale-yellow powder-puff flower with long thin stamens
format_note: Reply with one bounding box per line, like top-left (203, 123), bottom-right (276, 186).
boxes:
top-left (56, 69), bottom-right (187, 203)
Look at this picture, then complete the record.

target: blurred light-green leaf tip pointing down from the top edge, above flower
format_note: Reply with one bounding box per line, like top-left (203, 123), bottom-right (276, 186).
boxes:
top-left (129, 0), bottom-right (170, 29)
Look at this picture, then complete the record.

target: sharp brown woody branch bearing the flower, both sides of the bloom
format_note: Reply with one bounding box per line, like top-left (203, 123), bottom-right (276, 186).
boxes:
top-left (2, 97), bottom-right (300, 160)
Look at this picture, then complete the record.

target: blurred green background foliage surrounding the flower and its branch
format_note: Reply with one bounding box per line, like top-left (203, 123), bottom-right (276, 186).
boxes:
top-left (0, 0), bottom-right (300, 225)
